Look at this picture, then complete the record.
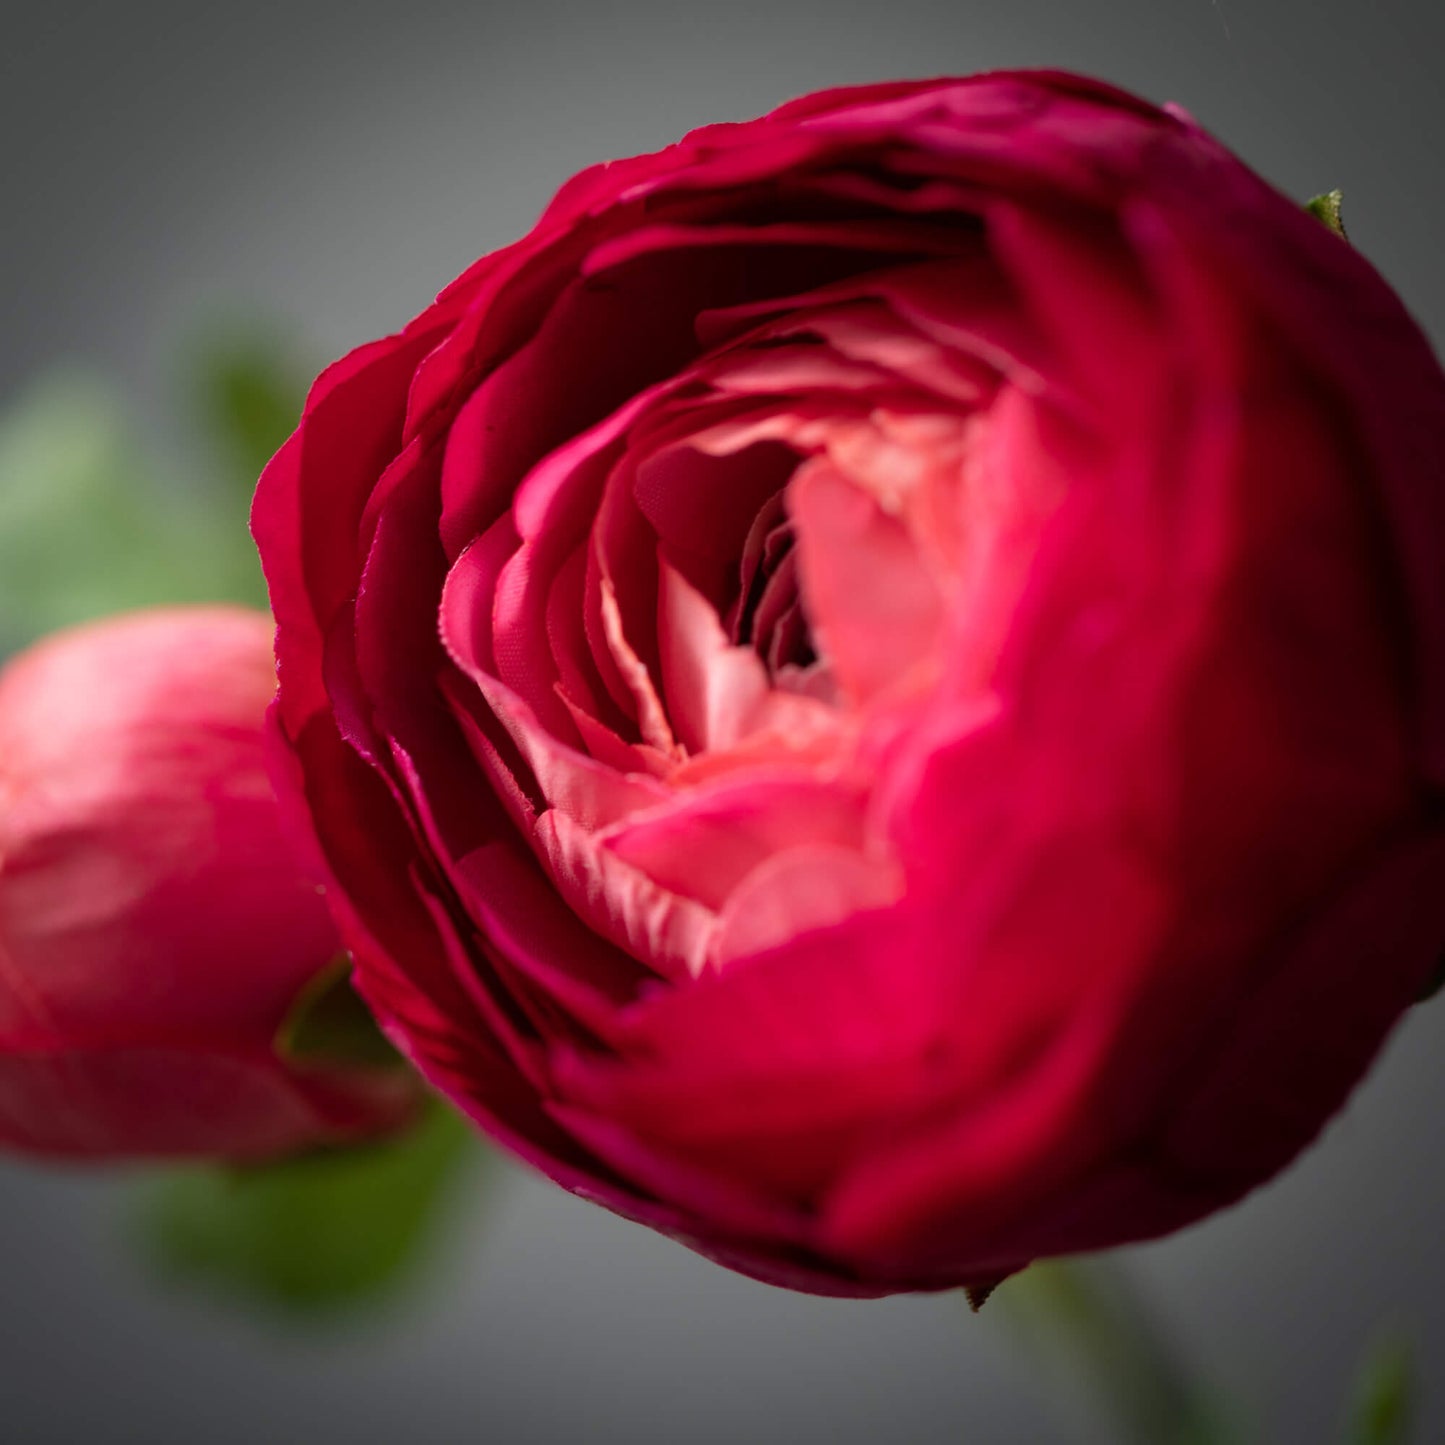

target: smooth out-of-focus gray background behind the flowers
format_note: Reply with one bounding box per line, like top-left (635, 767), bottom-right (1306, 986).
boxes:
top-left (0, 0), bottom-right (1445, 1445)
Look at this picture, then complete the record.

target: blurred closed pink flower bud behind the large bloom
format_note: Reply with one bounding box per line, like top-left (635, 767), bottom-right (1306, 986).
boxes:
top-left (0, 607), bottom-right (415, 1159)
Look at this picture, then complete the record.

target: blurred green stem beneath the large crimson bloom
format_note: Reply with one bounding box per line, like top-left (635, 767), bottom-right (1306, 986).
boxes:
top-left (990, 1259), bottom-right (1237, 1445)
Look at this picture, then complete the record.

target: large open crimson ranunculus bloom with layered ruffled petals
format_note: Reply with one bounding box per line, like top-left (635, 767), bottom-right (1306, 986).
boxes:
top-left (254, 74), bottom-right (1445, 1295)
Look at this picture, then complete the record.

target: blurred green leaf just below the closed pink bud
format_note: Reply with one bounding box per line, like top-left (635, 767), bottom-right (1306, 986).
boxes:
top-left (140, 1100), bottom-right (480, 1319)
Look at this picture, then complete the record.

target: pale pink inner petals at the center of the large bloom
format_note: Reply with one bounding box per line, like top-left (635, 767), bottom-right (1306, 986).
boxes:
top-left (430, 271), bottom-right (1086, 981)
